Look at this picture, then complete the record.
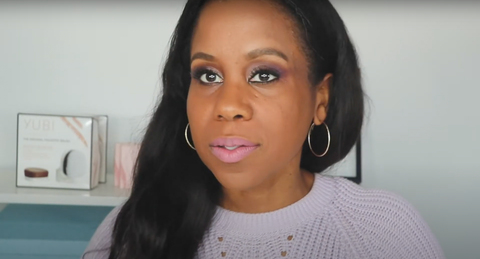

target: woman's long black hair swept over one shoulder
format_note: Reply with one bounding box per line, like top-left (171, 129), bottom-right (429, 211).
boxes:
top-left (109, 0), bottom-right (364, 259)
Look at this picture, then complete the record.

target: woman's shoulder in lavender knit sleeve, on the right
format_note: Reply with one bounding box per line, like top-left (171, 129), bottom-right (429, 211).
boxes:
top-left (316, 176), bottom-right (444, 258)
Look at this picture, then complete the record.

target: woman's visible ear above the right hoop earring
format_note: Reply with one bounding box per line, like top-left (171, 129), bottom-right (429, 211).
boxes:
top-left (313, 73), bottom-right (333, 125)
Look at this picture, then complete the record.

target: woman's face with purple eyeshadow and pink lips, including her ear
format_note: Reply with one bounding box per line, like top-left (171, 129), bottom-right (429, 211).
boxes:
top-left (187, 0), bottom-right (328, 190)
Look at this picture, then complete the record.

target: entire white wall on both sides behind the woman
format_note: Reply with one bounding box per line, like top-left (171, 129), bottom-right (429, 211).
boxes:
top-left (0, 1), bottom-right (480, 259)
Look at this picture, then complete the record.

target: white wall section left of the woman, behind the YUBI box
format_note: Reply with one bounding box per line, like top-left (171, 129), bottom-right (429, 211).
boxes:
top-left (0, 1), bottom-right (182, 175)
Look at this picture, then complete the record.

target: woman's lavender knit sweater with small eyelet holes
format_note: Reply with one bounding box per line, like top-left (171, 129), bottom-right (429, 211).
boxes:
top-left (80, 174), bottom-right (445, 259)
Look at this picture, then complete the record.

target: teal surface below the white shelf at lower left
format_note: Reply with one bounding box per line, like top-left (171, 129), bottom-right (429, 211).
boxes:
top-left (0, 204), bottom-right (113, 259)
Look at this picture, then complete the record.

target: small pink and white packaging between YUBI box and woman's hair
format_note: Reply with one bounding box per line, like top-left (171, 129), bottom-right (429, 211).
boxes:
top-left (114, 143), bottom-right (140, 189)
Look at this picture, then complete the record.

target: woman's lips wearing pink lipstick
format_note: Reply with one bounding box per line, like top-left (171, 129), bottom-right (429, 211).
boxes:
top-left (210, 138), bottom-right (259, 164)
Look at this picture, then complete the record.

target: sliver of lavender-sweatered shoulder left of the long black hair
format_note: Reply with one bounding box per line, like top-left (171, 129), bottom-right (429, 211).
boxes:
top-left (82, 205), bottom-right (122, 259)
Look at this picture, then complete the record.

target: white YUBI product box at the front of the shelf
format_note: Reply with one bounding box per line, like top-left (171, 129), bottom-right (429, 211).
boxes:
top-left (17, 113), bottom-right (105, 190)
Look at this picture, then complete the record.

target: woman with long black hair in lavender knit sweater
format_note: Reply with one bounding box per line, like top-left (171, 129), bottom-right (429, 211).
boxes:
top-left (84, 0), bottom-right (443, 259)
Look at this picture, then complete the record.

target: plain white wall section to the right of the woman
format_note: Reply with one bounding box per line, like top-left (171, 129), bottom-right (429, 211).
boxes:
top-left (338, 1), bottom-right (480, 259)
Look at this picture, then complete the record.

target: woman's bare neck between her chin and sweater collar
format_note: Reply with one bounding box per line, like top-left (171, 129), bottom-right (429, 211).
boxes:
top-left (220, 169), bottom-right (315, 213)
